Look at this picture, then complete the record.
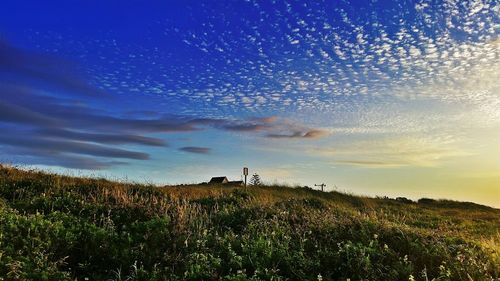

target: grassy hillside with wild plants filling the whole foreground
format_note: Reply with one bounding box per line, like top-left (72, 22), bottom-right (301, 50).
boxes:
top-left (0, 163), bottom-right (500, 281)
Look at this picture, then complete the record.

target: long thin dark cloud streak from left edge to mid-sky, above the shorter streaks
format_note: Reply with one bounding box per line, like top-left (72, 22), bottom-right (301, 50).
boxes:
top-left (0, 83), bottom-right (302, 136)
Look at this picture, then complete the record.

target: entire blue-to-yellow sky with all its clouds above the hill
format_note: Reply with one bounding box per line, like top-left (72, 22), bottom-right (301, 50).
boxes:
top-left (0, 0), bottom-right (500, 207)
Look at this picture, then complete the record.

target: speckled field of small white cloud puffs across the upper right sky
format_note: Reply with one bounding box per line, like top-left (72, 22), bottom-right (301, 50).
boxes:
top-left (154, 1), bottom-right (500, 127)
